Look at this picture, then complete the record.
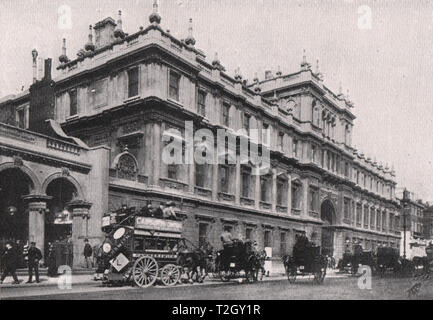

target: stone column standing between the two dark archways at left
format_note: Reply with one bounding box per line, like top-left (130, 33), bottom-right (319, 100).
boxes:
top-left (23, 195), bottom-right (52, 260)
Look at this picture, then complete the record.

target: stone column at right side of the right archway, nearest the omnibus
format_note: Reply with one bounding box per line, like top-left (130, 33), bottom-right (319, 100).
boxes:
top-left (67, 200), bottom-right (92, 268)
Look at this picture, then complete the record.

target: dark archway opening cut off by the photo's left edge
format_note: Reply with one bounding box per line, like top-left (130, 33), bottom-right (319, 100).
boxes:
top-left (0, 168), bottom-right (34, 248)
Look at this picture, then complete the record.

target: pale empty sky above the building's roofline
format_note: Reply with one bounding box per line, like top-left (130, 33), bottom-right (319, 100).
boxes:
top-left (0, 0), bottom-right (433, 203)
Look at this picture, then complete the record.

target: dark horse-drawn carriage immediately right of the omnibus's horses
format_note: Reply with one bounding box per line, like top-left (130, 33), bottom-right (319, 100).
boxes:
top-left (215, 239), bottom-right (263, 282)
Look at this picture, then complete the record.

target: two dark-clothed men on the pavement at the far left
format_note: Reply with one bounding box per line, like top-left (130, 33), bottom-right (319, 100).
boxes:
top-left (0, 242), bottom-right (42, 284)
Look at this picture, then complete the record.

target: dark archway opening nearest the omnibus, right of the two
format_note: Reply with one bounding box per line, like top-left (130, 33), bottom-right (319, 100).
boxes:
top-left (45, 178), bottom-right (77, 244)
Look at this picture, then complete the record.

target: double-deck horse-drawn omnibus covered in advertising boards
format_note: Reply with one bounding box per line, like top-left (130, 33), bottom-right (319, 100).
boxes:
top-left (100, 213), bottom-right (183, 287)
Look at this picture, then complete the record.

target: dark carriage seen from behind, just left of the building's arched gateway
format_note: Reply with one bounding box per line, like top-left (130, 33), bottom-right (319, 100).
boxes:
top-left (283, 236), bottom-right (328, 284)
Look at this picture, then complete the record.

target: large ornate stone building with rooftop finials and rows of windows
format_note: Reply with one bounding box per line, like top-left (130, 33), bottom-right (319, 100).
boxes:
top-left (0, 4), bottom-right (400, 261)
